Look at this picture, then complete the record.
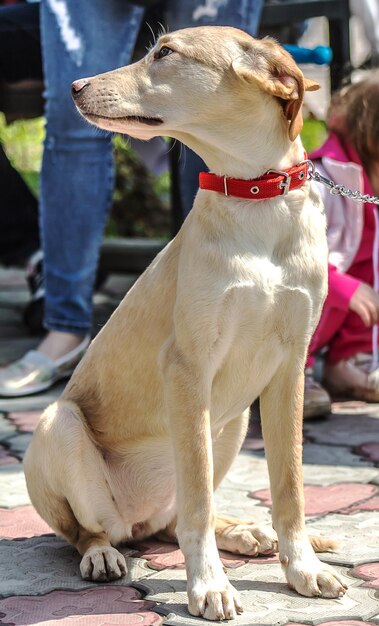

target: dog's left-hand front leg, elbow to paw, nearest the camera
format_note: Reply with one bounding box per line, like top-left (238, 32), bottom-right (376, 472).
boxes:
top-left (163, 348), bottom-right (242, 620)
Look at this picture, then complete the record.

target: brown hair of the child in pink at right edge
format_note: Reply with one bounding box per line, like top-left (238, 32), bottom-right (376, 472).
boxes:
top-left (327, 70), bottom-right (379, 169)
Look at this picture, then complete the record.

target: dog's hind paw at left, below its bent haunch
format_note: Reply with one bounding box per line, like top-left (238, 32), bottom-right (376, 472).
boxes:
top-left (80, 546), bottom-right (127, 582)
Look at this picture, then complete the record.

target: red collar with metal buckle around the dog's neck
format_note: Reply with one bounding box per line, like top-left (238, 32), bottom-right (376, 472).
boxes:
top-left (199, 157), bottom-right (308, 200)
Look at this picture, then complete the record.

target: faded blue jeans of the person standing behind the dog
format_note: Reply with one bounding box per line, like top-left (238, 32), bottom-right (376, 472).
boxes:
top-left (40, 0), bottom-right (263, 334)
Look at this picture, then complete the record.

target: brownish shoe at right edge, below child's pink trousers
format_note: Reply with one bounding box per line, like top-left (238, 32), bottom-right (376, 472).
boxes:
top-left (324, 352), bottom-right (379, 402)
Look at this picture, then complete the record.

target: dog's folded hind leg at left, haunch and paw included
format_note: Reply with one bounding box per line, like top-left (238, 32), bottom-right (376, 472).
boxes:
top-left (24, 401), bottom-right (126, 581)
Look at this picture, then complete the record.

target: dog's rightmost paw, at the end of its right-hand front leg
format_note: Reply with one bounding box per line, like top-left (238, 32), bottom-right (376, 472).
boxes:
top-left (282, 558), bottom-right (347, 598)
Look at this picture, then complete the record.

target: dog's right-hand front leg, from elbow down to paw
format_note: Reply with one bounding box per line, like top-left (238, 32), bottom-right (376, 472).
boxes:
top-left (261, 358), bottom-right (345, 598)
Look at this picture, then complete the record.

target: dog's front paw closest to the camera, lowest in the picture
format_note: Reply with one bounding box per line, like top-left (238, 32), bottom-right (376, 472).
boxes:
top-left (188, 575), bottom-right (243, 621)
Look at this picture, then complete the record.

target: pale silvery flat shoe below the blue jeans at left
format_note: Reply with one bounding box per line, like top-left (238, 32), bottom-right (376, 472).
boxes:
top-left (0, 336), bottom-right (90, 398)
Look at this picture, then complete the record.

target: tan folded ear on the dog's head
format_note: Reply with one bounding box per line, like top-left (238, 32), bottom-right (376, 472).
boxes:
top-left (233, 38), bottom-right (320, 141)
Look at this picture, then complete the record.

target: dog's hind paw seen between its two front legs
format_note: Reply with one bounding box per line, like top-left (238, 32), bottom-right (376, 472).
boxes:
top-left (216, 524), bottom-right (278, 556)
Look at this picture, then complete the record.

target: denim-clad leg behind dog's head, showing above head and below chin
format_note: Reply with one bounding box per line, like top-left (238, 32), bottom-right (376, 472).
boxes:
top-left (167, 0), bottom-right (263, 217)
